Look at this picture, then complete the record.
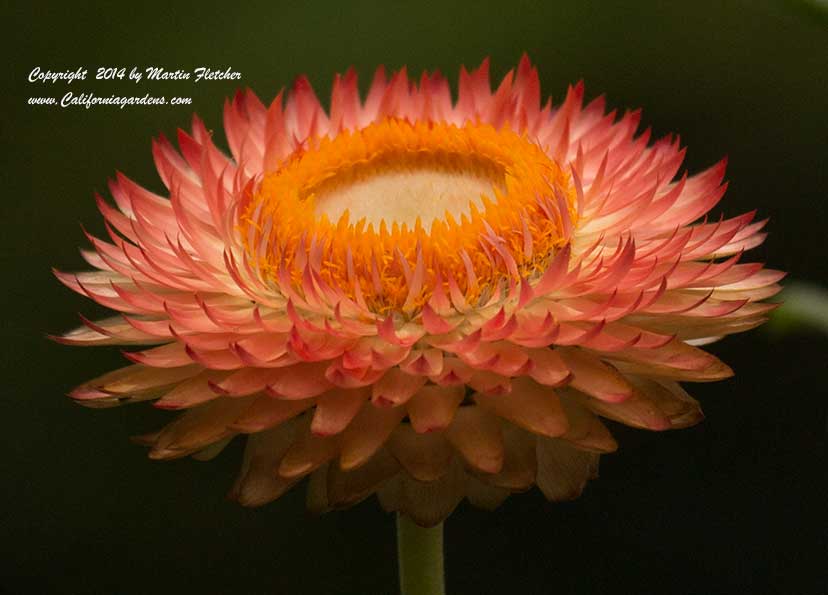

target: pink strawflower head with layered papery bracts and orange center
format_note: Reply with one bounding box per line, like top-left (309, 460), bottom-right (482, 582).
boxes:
top-left (56, 57), bottom-right (783, 525)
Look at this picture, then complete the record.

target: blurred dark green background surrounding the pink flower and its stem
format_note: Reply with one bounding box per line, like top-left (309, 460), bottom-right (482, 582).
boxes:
top-left (0, 0), bottom-right (828, 595)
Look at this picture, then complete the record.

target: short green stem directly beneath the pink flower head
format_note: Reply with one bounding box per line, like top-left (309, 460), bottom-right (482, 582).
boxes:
top-left (397, 514), bottom-right (446, 595)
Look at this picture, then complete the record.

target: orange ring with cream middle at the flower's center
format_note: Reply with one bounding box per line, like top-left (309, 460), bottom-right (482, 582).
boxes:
top-left (239, 119), bottom-right (577, 314)
